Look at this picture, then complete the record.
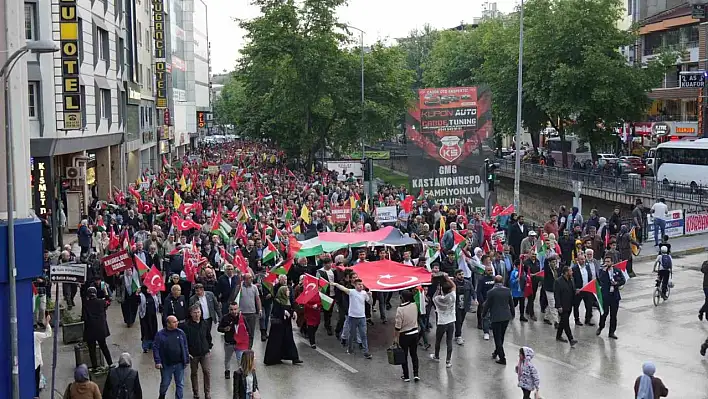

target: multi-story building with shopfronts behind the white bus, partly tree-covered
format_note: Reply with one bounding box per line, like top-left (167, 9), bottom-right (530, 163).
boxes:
top-left (628, 0), bottom-right (706, 146)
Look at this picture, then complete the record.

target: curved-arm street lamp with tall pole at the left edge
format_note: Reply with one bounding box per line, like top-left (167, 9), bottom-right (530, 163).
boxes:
top-left (0, 40), bottom-right (59, 399)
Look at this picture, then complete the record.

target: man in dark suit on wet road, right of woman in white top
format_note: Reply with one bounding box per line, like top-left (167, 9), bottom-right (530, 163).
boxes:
top-left (482, 276), bottom-right (514, 365)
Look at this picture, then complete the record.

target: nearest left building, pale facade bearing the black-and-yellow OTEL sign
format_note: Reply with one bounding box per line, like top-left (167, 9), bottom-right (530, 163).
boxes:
top-left (25, 0), bottom-right (127, 226)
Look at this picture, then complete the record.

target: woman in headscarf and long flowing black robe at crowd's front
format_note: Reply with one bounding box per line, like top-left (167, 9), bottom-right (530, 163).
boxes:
top-left (263, 286), bottom-right (302, 366)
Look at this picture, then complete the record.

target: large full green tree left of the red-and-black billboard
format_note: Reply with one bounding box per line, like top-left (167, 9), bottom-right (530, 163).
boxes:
top-left (236, 0), bottom-right (412, 165)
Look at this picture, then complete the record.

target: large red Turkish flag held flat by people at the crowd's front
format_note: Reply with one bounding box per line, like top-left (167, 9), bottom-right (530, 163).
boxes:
top-left (352, 259), bottom-right (432, 291)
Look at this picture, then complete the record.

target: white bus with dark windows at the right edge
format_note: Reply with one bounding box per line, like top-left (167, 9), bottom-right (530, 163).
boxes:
top-left (656, 138), bottom-right (708, 190)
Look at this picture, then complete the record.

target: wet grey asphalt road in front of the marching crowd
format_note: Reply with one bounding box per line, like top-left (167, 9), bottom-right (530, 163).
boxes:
top-left (41, 254), bottom-right (708, 399)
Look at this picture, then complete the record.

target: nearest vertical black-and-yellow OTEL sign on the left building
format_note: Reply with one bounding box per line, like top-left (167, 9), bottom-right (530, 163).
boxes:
top-left (59, 0), bottom-right (83, 130)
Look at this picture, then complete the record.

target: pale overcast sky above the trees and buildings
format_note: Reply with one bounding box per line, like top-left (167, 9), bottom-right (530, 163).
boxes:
top-left (206, 0), bottom-right (517, 74)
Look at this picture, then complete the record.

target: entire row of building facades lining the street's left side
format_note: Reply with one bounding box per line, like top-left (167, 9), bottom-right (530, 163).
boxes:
top-left (18, 0), bottom-right (211, 229)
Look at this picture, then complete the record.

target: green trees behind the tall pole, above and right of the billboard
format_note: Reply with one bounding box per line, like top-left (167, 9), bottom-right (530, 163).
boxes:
top-left (423, 0), bottom-right (676, 164)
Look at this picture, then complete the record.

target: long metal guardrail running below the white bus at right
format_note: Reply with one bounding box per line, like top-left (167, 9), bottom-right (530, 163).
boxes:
top-left (496, 159), bottom-right (708, 206)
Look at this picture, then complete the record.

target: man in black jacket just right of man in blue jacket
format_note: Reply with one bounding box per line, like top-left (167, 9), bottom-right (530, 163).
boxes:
top-left (179, 304), bottom-right (212, 399)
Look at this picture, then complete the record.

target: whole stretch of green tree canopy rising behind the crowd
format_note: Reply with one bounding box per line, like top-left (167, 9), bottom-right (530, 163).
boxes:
top-left (214, 0), bottom-right (677, 163)
